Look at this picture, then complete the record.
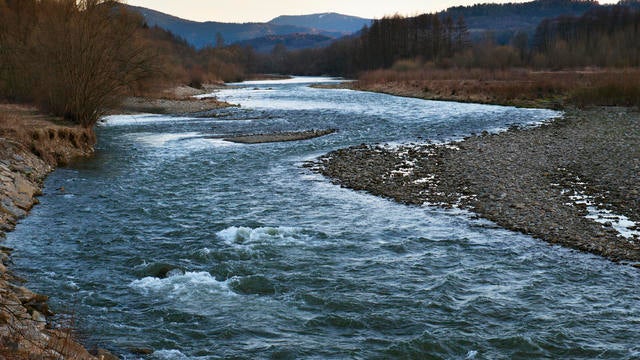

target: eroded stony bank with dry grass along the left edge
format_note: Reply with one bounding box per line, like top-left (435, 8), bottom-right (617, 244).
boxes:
top-left (0, 104), bottom-right (101, 359)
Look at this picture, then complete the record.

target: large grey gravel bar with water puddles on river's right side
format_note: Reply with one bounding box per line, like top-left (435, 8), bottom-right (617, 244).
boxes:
top-left (312, 108), bottom-right (640, 266)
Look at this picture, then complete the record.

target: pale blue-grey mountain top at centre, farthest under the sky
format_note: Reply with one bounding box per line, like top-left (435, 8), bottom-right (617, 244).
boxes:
top-left (269, 13), bottom-right (371, 35)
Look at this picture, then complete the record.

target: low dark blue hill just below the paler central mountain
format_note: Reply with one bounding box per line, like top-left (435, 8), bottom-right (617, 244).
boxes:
top-left (236, 34), bottom-right (336, 53)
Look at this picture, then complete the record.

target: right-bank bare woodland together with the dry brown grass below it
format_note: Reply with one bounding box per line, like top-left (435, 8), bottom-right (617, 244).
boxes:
top-left (266, 1), bottom-right (640, 108)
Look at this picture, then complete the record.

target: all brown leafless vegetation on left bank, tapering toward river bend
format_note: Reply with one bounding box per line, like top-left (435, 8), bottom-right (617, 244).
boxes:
top-left (0, 0), bottom-right (253, 128)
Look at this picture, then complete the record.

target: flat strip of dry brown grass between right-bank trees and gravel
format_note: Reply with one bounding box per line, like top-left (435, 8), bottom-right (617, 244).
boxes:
top-left (355, 68), bottom-right (640, 108)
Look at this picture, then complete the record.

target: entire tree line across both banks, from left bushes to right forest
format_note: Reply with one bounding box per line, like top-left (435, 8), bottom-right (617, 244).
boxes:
top-left (0, 0), bottom-right (640, 127)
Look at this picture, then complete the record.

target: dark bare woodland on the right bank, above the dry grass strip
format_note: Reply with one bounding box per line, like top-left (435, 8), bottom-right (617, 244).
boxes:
top-left (261, 0), bottom-right (640, 76)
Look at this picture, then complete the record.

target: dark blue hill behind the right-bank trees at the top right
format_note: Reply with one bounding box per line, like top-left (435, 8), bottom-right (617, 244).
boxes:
top-left (440, 0), bottom-right (600, 44)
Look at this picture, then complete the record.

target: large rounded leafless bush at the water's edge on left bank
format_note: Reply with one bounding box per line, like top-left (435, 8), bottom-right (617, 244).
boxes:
top-left (30, 0), bottom-right (152, 127)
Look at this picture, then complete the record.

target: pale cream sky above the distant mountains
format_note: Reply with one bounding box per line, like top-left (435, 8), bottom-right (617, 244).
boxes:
top-left (124, 0), bottom-right (617, 22)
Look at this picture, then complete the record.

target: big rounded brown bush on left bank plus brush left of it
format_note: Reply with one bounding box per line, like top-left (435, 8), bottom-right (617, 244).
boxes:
top-left (0, 0), bottom-right (154, 127)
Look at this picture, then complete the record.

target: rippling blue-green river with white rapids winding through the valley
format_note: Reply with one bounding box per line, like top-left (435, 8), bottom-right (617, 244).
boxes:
top-left (6, 78), bottom-right (640, 359)
